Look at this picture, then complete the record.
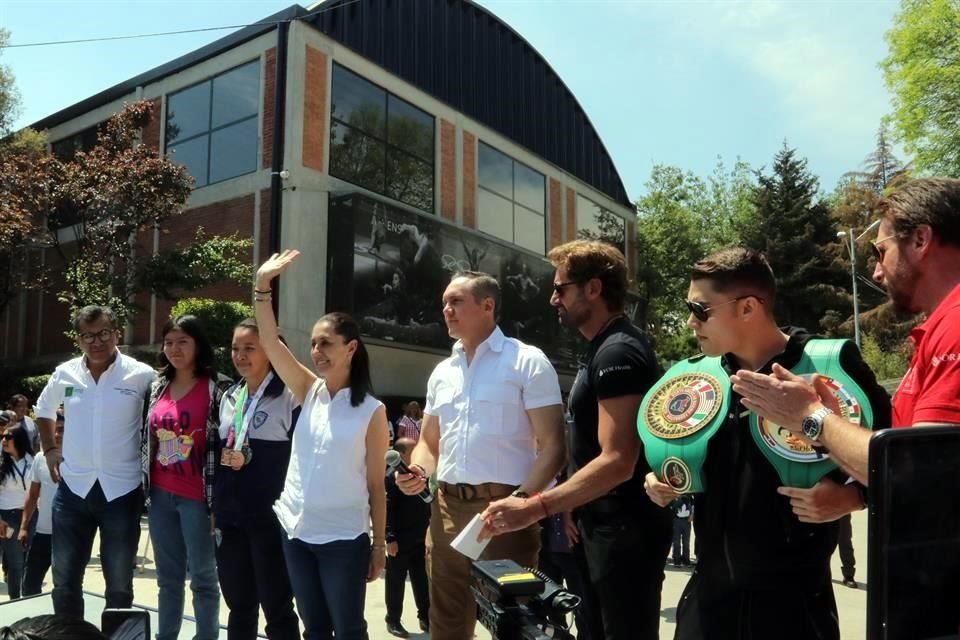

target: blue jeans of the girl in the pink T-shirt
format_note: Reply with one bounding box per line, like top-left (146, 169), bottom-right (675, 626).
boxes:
top-left (149, 488), bottom-right (220, 640)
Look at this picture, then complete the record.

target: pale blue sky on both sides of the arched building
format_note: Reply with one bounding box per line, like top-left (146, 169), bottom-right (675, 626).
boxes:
top-left (0, 0), bottom-right (899, 199)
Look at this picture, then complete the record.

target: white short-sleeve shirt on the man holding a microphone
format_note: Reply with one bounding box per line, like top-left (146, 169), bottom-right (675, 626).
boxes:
top-left (424, 327), bottom-right (561, 485)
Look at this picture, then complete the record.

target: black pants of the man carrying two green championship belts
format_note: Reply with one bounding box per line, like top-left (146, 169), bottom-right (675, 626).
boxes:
top-left (674, 571), bottom-right (840, 640)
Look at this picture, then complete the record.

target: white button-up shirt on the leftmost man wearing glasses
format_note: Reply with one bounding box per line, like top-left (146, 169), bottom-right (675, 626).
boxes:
top-left (36, 351), bottom-right (157, 500)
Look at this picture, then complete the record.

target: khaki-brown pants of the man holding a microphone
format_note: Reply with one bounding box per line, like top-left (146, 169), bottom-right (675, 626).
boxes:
top-left (427, 483), bottom-right (540, 640)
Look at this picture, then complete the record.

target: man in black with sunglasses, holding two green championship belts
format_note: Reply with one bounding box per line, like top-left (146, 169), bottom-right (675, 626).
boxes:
top-left (646, 248), bottom-right (890, 640)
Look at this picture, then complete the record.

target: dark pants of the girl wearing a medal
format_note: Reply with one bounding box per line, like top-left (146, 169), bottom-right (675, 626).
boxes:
top-left (217, 514), bottom-right (300, 640)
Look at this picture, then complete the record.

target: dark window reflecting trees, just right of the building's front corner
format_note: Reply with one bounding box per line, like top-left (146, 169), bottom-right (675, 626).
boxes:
top-left (330, 64), bottom-right (434, 212)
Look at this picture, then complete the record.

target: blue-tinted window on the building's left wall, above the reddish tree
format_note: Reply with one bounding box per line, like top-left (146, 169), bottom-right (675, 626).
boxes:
top-left (166, 60), bottom-right (260, 187)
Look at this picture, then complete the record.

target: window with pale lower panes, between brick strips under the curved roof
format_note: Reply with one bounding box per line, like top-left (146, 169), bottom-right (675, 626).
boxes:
top-left (477, 142), bottom-right (547, 255)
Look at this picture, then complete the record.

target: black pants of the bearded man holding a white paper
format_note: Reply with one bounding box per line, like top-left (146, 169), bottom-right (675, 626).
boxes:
top-left (578, 512), bottom-right (672, 640)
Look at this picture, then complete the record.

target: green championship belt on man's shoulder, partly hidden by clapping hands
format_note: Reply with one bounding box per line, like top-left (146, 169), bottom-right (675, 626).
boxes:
top-left (750, 339), bottom-right (873, 489)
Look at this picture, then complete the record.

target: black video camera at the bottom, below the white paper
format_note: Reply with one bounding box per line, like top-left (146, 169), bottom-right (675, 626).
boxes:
top-left (470, 560), bottom-right (580, 640)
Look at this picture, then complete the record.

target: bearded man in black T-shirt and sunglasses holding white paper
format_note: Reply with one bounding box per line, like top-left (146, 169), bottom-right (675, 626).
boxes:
top-left (484, 240), bottom-right (672, 640)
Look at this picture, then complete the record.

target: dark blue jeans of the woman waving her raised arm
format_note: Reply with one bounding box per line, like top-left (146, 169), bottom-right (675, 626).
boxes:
top-left (283, 534), bottom-right (370, 640)
